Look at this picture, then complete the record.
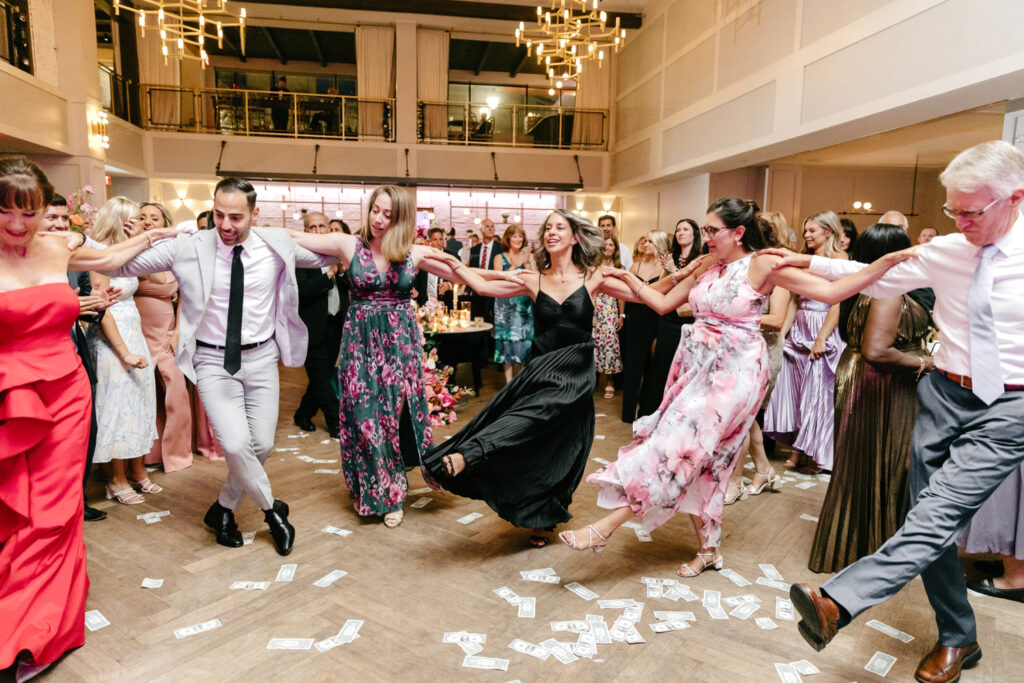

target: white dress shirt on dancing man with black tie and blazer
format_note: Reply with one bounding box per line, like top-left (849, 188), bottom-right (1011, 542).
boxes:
top-left (196, 232), bottom-right (285, 346)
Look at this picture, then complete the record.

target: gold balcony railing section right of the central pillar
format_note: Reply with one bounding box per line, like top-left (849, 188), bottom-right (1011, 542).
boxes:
top-left (417, 100), bottom-right (608, 150)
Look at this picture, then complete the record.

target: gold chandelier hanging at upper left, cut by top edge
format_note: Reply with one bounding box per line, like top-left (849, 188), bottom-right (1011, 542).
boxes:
top-left (114, 0), bottom-right (246, 69)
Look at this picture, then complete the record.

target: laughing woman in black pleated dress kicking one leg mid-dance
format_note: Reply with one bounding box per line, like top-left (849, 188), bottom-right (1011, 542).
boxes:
top-left (423, 210), bottom-right (636, 547)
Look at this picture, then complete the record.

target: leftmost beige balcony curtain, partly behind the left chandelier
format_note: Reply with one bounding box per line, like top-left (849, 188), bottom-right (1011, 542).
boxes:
top-left (135, 24), bottom-right (182, 128)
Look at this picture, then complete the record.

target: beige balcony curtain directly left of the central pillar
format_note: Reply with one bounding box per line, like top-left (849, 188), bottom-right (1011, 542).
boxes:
top-left (355, 26), bottom-right (394, 140)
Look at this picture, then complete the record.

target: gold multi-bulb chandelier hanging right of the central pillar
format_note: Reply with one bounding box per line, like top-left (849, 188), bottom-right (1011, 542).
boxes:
top-left (515, 0), bottom-right (626, 92)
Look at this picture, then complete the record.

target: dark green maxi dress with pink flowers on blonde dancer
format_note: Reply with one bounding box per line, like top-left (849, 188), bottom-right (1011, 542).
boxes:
top-left (338, 240), bottom-right (433, 515)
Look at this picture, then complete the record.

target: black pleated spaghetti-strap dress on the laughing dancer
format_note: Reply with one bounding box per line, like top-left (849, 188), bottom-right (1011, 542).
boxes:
top-left (423, 287), bottom-right (596, 528)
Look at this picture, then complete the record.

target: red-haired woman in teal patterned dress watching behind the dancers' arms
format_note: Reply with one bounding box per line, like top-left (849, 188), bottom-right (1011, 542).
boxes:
top-left (494, 224), bottom-right (537, 384)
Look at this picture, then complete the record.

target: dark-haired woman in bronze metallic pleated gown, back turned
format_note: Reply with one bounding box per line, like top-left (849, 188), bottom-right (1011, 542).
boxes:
top-left (808, 223), bottom-right (935, 572)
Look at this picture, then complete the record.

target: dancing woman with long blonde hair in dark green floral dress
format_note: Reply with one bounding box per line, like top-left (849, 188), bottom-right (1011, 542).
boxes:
top-left (289, 185), bottom-right (452, 527)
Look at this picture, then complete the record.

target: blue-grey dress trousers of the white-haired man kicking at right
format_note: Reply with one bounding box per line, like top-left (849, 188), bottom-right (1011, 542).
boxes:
top-left (821, 373), bottom-right (1024, 647)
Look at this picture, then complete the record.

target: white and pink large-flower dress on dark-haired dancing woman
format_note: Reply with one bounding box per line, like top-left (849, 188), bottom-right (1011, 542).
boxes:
top-left (588, 256), bottom-right (769, 546)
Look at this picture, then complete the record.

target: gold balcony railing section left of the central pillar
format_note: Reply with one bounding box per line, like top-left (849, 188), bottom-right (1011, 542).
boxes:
top-left (142, 85), bottom-right (394, 142)
